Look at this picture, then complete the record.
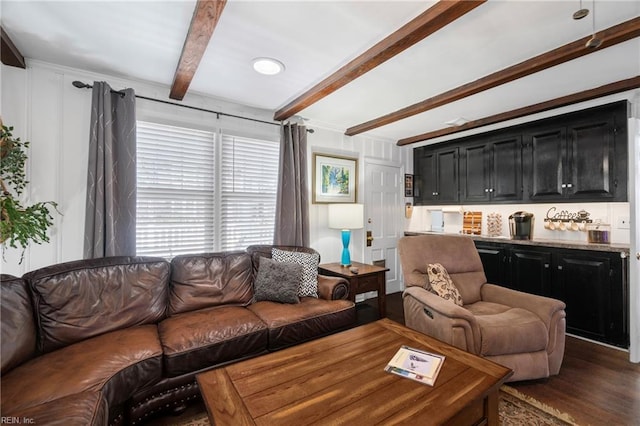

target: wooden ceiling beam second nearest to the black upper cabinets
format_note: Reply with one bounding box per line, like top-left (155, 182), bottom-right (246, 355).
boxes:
top-left (345, 17), bottom-right (640, 136)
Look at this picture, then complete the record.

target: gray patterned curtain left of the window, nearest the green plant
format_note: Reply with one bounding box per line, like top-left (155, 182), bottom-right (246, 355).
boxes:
top-left (84, 82), bottom-right (136, 259)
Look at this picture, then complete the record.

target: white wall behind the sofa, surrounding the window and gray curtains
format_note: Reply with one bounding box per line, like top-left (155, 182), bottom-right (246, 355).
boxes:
top-left (0, 61), bottom-right (403, 276)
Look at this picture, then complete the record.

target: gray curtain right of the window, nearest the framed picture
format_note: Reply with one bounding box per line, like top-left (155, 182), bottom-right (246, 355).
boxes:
top-left (273, 124), bottom-right (309, 247)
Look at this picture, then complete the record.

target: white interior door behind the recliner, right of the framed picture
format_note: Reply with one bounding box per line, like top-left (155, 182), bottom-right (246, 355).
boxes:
top-left (364, 160), bottom-right (404, 293)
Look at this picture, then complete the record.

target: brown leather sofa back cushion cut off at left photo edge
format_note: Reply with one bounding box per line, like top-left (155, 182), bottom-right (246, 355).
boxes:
top-left (0, 274), bottom-right (36, 375)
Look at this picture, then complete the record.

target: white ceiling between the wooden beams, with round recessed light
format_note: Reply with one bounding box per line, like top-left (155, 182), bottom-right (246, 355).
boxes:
top-left (0, 0), bottom-right (640, 139)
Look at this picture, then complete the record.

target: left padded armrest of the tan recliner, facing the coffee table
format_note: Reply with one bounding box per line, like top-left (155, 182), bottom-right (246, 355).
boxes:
top-left (402, 286), bottom-right (481, 354)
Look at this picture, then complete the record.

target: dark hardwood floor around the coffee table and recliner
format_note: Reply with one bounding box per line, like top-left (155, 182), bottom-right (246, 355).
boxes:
top-left (155, 293), bottom-right (640, 426)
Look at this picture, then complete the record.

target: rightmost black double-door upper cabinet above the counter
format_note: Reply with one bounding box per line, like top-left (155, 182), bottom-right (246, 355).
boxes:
top-left (523, 101), bottom-right (627, 202)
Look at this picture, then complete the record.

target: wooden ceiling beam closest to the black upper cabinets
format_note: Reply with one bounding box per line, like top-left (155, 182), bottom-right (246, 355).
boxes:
top-left (397, 76), bottom-right (640, 146)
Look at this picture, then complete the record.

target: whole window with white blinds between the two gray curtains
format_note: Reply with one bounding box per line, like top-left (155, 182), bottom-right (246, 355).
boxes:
top-left (136, 121), bottom-right (279, 258)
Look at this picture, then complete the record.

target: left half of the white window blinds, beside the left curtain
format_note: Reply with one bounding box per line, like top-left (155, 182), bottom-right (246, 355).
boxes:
top-left (136, 122), bottom-right (215, 257)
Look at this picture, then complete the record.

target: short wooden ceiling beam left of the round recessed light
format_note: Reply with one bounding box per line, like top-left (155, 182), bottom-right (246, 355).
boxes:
top-left (169, 0), bottom-right (227, 101)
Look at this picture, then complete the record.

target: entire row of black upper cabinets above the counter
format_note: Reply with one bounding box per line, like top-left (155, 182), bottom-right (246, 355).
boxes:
top-left (414, 101), bottom-right (628, 205)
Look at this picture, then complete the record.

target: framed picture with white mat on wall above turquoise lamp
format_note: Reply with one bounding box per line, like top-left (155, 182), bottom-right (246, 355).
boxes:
top-left (312, 153), bottom-right (358, 204)
